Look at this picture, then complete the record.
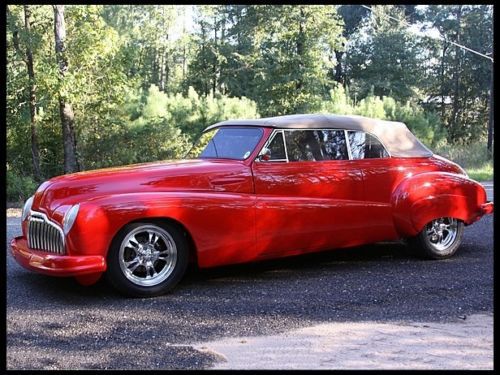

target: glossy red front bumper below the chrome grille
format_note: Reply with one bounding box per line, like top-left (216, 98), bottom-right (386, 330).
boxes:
top-left (10, 237), bottom-right (106, 276)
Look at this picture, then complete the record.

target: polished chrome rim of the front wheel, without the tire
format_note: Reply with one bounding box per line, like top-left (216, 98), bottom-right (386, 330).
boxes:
top-left (118, 225), bottom-right (177, 286)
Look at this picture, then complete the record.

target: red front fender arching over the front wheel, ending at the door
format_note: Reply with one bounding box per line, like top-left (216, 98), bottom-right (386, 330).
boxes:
top-left (67, 191), bottom-right (255, 267)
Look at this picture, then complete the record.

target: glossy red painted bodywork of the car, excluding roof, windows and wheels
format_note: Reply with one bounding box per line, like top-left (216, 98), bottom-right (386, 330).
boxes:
top-left (11, 128), bottom-right (493, 284)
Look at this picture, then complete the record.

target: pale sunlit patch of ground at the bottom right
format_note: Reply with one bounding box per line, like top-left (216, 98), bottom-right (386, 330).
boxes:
top-left (195, 314), bottom-right (493, 370)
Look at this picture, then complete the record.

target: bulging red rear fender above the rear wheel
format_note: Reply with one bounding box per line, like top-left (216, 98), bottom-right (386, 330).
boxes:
top-left (391, 172), bottom-right (486, 237)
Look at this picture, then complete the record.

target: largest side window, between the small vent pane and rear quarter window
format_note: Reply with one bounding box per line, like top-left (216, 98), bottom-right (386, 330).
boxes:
top-left (285, 130), bottom-right (349, 161)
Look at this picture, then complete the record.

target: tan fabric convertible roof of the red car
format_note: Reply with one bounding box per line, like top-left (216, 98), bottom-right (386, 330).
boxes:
top-left (205, 114), bottom-right (433, 157)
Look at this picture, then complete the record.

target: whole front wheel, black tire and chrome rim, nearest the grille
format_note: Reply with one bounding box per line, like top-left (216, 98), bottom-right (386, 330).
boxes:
top-left (106, 222), bottom-right (188, 297)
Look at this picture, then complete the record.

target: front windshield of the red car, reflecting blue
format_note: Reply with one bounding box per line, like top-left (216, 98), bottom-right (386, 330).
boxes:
top-left (188, 127), bottom-right (263, 160)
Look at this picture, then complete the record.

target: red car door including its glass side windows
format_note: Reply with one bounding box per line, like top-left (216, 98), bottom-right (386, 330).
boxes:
top-left (252, 129), bottom-right (363, 257)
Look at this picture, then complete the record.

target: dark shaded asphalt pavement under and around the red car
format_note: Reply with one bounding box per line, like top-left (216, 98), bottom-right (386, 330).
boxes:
top-left (6, 186), bottom-right (493, 369)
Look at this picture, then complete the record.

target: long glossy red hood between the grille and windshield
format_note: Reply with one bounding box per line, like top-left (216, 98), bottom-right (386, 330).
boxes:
top-left (32, 159), bottom-right (251, 215)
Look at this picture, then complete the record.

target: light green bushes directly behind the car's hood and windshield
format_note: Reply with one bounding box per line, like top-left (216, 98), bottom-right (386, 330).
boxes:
top-left (76, 85), bottom-right (257, 169)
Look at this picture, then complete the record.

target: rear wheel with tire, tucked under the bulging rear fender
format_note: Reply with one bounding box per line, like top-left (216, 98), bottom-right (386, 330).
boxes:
top-left (408, 217), bottom-right (464, 259)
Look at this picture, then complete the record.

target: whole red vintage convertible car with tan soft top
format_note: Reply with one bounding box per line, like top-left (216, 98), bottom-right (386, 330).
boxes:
top-left (11, 115), bottom-right (493, 296)
